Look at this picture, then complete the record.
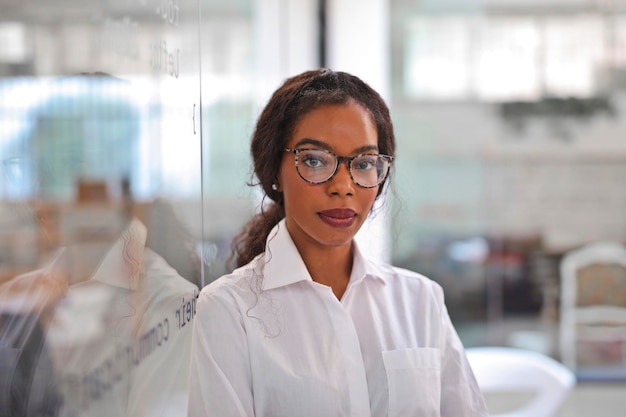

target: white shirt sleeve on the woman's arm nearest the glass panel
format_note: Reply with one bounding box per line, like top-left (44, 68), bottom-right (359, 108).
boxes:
top-left (188, 288), bottom-right (254, 417)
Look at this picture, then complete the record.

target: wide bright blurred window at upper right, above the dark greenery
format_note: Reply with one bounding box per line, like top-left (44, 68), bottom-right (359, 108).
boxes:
top-left (402, 13), bottom-right (626, 101)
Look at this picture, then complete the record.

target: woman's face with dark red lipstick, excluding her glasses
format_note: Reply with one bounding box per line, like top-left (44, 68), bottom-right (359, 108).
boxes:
top-left (278, 102), bottom-right (379, 252)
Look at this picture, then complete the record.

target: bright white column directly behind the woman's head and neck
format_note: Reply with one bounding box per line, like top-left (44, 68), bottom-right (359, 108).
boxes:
top-left (326, 0), bottom-right (391, 261)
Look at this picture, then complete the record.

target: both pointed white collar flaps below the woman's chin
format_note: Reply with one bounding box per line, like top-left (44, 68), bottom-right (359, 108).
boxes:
top-left (260, 219), bottom-right (389, 290)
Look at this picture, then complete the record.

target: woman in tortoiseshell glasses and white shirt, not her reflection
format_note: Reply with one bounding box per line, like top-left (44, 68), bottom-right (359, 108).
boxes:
top-left (189, 69), bottom-right (487, 417)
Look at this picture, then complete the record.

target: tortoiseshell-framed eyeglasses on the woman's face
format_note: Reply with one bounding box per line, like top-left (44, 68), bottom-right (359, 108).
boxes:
top-left (285, 148), bottom-right (393, 188)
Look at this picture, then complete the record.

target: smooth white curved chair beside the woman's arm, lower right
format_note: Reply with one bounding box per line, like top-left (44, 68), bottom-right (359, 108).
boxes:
top-left (466, 347), bottom-right (576, 417)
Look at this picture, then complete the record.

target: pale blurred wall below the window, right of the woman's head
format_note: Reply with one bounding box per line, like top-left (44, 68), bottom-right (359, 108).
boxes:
top-left (392, 93), bottom-right (626, 258)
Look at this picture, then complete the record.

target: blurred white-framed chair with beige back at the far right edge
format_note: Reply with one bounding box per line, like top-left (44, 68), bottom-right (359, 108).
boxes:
top-left (559, 242), bottom-right (626, 377)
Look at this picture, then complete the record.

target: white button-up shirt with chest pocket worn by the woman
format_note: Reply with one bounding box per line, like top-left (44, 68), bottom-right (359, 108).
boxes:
top-left (188, 220), bottom-right (487, 417)
